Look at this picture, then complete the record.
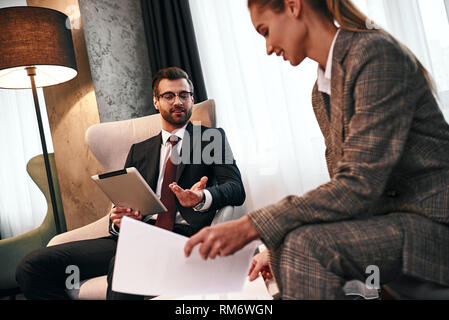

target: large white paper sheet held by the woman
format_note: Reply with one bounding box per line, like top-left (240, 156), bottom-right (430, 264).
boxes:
top-left (112, 217), bottom-right (258, 296)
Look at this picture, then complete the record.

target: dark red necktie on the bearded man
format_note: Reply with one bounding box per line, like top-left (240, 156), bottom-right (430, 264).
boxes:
top-left (155, 136), bottom-right (179, 231)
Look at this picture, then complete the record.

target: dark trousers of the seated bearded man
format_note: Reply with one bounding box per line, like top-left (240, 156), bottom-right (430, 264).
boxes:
top-left (16, 222), bottom-right (194, 300)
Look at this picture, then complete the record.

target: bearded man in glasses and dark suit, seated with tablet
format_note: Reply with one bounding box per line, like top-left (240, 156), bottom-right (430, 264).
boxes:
top-left (16, 68), bottom-right (245, 299)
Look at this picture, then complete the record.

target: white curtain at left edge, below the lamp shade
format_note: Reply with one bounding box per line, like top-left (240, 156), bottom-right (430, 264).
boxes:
top-left (0, 89), bottom-right (53, 239)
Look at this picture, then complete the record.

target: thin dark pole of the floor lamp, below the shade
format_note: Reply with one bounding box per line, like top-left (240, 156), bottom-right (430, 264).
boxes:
top-left (26, 67), bottom-right (61, 234)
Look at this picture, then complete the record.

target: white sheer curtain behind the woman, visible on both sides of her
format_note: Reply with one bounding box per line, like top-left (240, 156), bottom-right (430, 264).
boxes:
top-left (190, 0), bottom-right (449, 215)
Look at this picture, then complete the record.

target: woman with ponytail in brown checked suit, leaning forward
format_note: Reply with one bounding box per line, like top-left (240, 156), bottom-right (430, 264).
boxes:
top-left (185, 0), bottom-right (449, 299)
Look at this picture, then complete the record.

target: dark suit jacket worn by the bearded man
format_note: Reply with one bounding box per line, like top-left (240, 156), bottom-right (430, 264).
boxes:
top-left (109, 123), bottom-right (245, 235)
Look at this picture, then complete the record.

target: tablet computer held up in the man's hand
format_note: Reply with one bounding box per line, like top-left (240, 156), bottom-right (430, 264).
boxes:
top-left (92, 167), bottom-right (167, 216)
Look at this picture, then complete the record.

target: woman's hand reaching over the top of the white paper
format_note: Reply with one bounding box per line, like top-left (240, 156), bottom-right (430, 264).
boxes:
top-left (184, 216), bottom-right (259, 260)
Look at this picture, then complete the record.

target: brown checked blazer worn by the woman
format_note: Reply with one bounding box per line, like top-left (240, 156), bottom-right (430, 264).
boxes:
top-left (248, 30), bottom-right (449, 285)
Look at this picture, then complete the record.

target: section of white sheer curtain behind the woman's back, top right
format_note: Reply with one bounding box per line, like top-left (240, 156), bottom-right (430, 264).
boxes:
top-left (354, 0), bottom-right (449, 121)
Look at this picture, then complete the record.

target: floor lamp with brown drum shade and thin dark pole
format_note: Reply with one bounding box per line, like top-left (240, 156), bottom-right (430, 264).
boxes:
top-left (0, 6), bottom-right (78, 234)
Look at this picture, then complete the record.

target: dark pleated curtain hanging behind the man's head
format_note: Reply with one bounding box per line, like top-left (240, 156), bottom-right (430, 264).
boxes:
top-left (141, 0), bottom-right (207, 103)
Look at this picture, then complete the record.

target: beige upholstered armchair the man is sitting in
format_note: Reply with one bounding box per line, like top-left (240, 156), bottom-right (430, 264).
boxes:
top-left (48, 100), bottom-right (241, 300)
